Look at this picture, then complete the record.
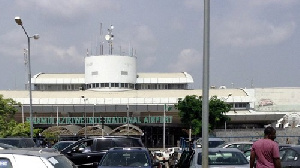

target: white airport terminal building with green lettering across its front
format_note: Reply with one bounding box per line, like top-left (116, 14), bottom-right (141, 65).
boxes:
top-left (0, 55), bottom-right (300, 147)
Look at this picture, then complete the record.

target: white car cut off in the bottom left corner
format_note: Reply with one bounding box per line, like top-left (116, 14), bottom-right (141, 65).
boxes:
top-left (0, 149), bottom-right (77, 168)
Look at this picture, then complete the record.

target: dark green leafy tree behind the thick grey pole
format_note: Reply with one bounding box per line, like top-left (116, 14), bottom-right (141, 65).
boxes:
top-left (175, 95), bottom-right (231, 135)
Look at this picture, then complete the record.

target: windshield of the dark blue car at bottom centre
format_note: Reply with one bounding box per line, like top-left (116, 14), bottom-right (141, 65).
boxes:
top-left (100, 150), bottom-right (150, 167)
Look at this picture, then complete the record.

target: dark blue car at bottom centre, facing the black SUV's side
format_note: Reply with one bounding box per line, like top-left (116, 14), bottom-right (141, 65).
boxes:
top-left (98, 147), bottom-right (159, 168)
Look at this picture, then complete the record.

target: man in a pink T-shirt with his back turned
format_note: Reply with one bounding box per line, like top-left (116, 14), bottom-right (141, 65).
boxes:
top-left (250, 127), bottom-right (281, 168)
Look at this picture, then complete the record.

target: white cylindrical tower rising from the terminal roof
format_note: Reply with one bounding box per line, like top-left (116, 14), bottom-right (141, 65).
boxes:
top-left (85, 55), bottom-right (137, 90)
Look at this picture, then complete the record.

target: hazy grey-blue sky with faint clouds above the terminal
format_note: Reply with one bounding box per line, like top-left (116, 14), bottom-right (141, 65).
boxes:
top-left (0, 0), bottom-right (300, 90)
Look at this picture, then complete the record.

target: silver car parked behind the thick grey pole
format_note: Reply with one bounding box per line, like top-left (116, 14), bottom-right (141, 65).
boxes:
top-left (190, 148), bottom-right (250, 168)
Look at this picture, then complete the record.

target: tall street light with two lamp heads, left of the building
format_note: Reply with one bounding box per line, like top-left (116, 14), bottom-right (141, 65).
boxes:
top-left (15, 16), bottom-right (40, 139)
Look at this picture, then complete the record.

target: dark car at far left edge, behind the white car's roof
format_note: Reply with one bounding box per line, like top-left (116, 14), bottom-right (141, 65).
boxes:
top-left (0, 138), bottom-right (35, 148)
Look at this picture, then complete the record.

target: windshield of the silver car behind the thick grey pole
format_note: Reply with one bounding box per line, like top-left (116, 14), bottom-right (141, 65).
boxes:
top-left (197, 151), bottom-right (248, 165)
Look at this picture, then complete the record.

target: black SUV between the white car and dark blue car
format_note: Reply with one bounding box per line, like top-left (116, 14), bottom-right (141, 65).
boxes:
top-left (61, 136), bottom-right (144, 167)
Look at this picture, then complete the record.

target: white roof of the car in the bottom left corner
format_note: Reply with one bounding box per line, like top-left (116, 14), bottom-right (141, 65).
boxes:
top-left (0, 149), bottom-right (63, 158)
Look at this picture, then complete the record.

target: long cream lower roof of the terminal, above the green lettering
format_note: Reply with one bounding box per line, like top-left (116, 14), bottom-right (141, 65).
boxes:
top-left (0, 89), bottom-right (250, 104)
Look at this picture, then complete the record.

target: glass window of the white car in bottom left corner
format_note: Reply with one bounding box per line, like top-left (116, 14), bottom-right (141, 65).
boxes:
top-left (47, 155), bottom-right (76, 168)
